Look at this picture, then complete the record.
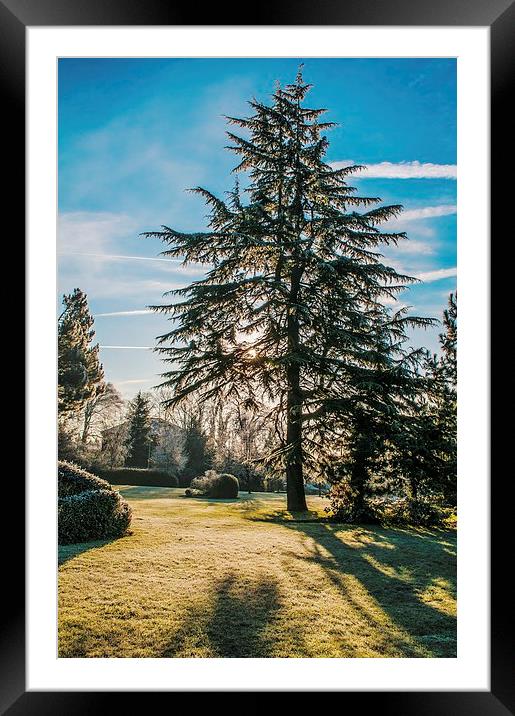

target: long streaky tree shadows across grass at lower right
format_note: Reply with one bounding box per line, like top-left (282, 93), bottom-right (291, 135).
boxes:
top-left (284, 522), bottom-right (456, 657)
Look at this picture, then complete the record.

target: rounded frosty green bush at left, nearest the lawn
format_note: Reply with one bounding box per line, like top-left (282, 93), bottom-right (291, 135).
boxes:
top-left (58, 489), bottom-right (132, 544)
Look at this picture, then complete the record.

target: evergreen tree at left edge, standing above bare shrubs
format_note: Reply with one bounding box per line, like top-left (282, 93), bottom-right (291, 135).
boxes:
top-left (57, 288), bottom-right (104, 418)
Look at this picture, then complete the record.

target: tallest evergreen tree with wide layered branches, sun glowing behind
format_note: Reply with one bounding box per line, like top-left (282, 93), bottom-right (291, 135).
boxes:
top-left (146, 71), bottom-right (436, 510)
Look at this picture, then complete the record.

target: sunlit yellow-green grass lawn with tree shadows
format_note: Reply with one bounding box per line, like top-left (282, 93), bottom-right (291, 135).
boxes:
top-left (59, 487), bottom-right (456, 657)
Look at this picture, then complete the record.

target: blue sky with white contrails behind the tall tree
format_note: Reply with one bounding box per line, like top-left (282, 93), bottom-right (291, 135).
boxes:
top-left (58, 58), bottom-right (456, 397)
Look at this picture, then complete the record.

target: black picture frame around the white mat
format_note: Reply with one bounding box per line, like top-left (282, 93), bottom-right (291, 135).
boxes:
top-left (6, 0), bottom-right (515, 716)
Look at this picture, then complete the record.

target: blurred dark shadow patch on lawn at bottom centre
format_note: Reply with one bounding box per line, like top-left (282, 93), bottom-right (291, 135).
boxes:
top-left (161, 573), bottom-right (281, 658)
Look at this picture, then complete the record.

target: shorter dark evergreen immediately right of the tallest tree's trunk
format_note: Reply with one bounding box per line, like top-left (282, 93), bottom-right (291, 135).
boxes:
top-left (321, 307), bottom-right (432, 522)
